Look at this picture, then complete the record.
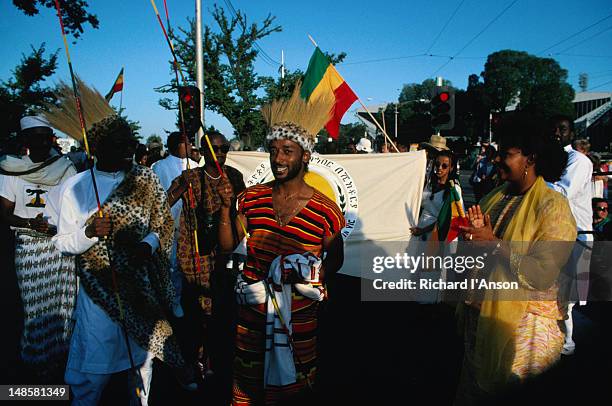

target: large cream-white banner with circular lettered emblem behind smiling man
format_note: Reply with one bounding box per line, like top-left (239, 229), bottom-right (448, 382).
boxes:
top-left (226, 151), bottom-right (426, 276)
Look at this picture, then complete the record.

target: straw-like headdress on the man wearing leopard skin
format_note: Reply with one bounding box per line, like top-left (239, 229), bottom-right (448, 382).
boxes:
top-left (42, 76), bottom-right (122, 145)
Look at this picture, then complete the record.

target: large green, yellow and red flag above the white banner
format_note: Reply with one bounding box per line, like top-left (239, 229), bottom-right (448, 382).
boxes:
top-left (300, 47), bottom-right (357, 139)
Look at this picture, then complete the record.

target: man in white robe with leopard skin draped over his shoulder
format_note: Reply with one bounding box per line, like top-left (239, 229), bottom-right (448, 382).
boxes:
top-left (54, 117), bottom-right (195, 405)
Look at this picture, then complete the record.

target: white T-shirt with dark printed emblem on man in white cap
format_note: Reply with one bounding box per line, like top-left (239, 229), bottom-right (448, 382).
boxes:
top-left (0, 157), bottom-right (76, 225)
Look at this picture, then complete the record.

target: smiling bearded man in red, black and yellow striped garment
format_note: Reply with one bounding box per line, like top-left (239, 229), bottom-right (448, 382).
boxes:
top-left (218, 116), bottom-right (345, 405)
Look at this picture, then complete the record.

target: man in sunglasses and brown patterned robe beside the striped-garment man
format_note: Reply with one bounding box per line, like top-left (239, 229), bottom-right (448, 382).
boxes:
top-left (168, 132), bottom-right (246, 386)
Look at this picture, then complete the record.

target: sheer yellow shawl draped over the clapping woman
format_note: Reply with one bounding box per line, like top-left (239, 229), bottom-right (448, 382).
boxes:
top-left (475, 177), bottom-right (576, 392)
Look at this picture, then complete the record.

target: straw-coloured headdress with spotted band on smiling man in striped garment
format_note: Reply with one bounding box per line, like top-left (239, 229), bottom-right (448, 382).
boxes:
top-left (261, 82), bottom-right (335, 151)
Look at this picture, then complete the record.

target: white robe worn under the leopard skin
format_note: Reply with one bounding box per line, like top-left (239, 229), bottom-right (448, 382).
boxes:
top-left (53, 169), bottom-right (159, 374)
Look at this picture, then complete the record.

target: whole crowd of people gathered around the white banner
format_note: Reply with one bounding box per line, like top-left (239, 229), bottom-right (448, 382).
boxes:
top-left (0, 84), bottom-right (612, 405)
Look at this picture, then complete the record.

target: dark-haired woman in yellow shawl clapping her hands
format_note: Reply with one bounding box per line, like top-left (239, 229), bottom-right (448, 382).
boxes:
top-left (456, 117), bottom-right (576, 404)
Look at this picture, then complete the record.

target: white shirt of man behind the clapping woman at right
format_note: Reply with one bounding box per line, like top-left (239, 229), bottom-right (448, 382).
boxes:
top-left (548, 145), bottom-right (593, 241)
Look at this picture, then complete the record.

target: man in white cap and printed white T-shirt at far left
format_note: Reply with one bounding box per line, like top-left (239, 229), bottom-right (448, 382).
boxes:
top-left (0, 116), bottom-right (76, 383)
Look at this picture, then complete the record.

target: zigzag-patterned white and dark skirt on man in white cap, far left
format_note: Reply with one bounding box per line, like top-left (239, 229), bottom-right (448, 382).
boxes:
top-left (15, 231), bottom-right (77, 383)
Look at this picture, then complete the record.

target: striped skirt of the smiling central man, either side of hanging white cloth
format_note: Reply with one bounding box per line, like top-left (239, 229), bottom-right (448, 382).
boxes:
top-left (232, 292), bottom-right (319, 406)
